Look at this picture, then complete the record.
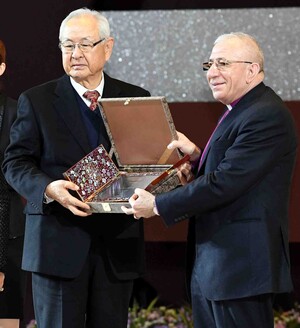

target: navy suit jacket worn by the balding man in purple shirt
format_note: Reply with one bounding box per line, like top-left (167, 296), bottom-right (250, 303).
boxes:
top-left (157, 83), bottom-right (297, 300)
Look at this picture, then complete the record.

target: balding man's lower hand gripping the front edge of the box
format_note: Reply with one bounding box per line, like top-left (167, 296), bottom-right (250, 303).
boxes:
top-left (121, 188), bottom-right (156, 220)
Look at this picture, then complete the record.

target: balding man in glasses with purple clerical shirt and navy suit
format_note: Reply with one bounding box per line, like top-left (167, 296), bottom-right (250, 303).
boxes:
top-left (123, 33), bottom-right (297, 328)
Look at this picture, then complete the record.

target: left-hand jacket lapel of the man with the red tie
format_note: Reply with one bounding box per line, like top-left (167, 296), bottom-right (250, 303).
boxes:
top-left (54, 75), bottom-right (92, 153)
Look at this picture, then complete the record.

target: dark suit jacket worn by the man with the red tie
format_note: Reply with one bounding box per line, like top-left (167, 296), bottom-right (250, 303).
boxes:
top-left (3, 75), bottom-right (150, 279)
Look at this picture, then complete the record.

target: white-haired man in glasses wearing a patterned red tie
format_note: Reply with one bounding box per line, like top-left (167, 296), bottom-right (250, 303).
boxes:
top-left (3, 9), bottom-right (150, 328)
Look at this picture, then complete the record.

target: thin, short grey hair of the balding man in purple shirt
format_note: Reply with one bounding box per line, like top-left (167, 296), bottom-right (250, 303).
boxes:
top-left (214, 32), bottom-right (265, 71)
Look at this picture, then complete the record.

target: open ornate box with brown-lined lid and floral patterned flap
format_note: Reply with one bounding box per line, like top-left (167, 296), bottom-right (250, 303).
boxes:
top-left (64, 97), bottom-right (189, 213)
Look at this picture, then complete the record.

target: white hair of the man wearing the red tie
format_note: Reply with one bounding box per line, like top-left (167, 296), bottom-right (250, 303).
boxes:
top-left (59, 8), bottom-right (110, 41)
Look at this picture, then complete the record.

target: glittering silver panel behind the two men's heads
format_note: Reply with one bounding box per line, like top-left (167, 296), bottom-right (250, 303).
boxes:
top-left (104, 7), bottom-right (300, 102)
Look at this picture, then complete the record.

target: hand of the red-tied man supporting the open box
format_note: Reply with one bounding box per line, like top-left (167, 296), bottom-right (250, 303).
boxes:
top-left (45, 180), bottom-right (92, 216)
